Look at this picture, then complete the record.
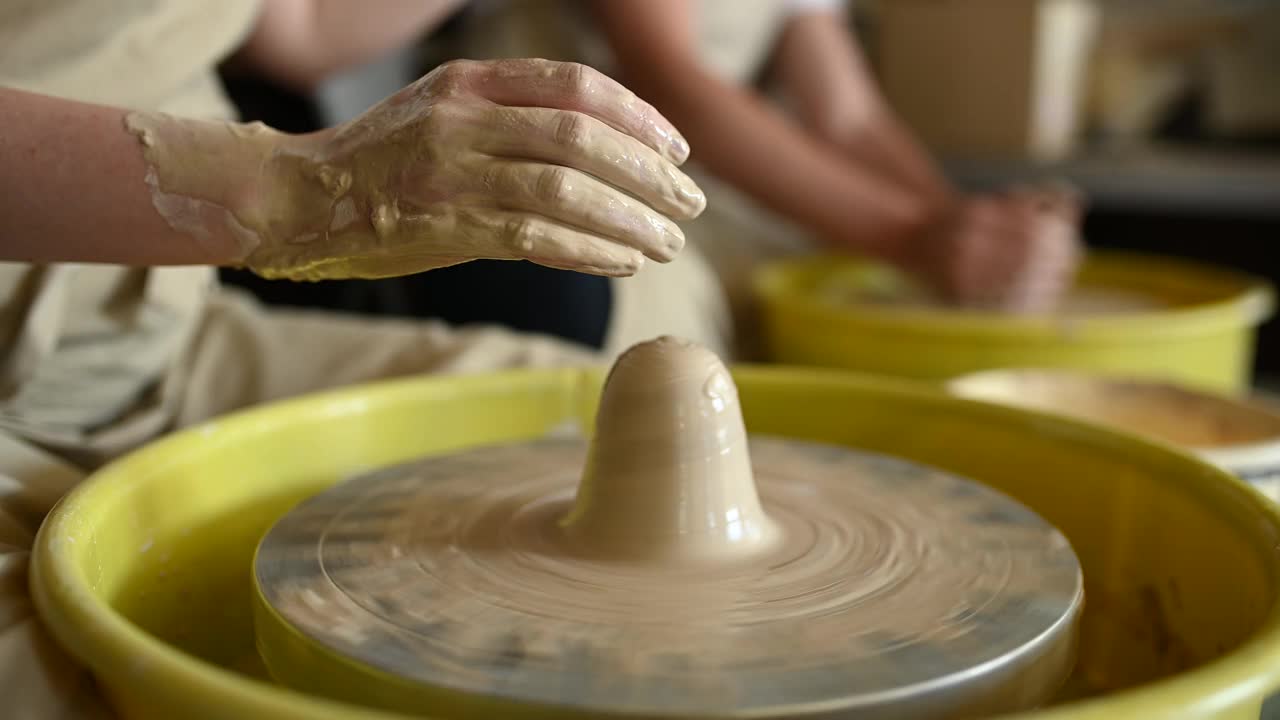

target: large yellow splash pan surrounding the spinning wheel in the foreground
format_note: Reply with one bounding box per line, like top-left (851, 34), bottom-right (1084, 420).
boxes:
top-left (32, 368), bottom-right (1280, 720)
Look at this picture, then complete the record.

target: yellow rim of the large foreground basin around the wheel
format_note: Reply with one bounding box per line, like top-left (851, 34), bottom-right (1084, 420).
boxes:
top-left (31, 366), bottom-right (1280, 720)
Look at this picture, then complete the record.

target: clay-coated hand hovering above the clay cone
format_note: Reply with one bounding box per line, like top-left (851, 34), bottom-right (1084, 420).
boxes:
top-left (244, 60), bottom-right (705, 279)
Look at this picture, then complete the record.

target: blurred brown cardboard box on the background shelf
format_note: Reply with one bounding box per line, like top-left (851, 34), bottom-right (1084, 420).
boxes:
top-left (876, 0), bottom-right (1101, 160)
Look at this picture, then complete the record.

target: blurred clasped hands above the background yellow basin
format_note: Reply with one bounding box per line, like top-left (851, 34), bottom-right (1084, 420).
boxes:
top-left (908, 190), bottom-right (1083, 313)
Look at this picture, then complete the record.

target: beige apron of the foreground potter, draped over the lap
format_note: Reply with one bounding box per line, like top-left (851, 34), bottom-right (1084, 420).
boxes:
top-left (0, 0), bottom-right (594, 720)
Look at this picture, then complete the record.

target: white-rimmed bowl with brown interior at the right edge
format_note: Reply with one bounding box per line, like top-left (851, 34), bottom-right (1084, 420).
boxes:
top-left (947, 370), bottom-right (1280, 502)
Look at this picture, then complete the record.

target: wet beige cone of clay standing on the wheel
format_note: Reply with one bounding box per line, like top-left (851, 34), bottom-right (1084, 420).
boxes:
top-left (562, 337), bottom-right (777, 564)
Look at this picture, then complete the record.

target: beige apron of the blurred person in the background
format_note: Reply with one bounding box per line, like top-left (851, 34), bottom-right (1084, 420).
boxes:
top-left (454, 0), bottom-right (842, 357)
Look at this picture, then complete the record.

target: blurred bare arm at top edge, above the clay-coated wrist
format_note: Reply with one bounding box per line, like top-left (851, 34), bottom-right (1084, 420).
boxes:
top-left (237, 0), bottom-right (463, 91)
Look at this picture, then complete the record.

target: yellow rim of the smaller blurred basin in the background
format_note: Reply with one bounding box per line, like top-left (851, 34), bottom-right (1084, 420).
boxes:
top-left (754, 252), bottom-right (1275, 343)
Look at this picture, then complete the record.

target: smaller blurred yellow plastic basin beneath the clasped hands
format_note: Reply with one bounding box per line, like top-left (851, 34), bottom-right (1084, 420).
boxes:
top-left (755, 254), bottom-right (1274, 392)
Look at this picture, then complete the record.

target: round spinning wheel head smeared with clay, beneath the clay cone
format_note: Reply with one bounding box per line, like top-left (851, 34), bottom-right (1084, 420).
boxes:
top-left (255, 437), bottom-right (1083, 719)
